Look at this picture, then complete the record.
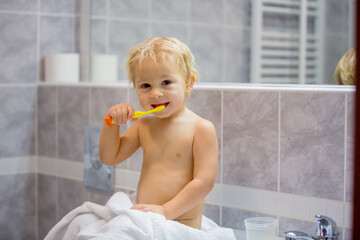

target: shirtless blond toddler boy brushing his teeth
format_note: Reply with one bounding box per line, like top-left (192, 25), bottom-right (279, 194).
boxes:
top-left (99, 37), bottom-right (218, 229)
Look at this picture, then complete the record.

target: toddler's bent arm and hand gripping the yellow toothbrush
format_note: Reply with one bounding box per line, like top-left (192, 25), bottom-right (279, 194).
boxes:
top-left (99, 103), bottom-right (140, 165)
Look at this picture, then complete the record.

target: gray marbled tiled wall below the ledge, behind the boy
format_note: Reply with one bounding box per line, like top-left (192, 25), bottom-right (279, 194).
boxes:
top-left (33, 85), bottom-right (354, 239)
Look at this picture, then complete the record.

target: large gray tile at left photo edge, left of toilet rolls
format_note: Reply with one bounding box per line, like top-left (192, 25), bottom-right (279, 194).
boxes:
top-left (0, 14), bottom-right (37, 83)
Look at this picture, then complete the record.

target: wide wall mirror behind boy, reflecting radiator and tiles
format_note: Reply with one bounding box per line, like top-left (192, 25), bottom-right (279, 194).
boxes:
top-left (88, 0), bottom-right (355, 85)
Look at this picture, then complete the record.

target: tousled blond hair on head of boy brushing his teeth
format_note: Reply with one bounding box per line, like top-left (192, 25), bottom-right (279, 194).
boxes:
top-left (125, 37), bottom-right (200, 85)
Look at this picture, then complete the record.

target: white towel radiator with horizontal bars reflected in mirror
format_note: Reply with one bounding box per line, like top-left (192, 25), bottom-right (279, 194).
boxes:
top-left (250, 0), bottom-right (324, 84)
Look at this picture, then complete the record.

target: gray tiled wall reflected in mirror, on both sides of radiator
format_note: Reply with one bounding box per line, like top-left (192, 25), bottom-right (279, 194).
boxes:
top-left (91, 0), bottom-right (354, 84)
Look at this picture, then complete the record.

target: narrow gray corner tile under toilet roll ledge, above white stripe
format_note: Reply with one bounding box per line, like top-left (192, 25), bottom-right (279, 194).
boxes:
top-left (37, 86), bottom-right (56, 157)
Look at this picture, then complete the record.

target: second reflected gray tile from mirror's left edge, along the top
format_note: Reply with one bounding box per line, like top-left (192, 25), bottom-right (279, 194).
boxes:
top-left (109, 0), bottom-right (150, 19)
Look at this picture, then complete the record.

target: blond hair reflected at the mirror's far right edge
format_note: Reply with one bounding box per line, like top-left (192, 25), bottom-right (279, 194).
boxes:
top-left (334, 48), bottom-right (356, 85)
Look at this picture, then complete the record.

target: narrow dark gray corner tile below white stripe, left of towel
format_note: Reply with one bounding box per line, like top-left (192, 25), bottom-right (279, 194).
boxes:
top-left (37, 174), bottom-right (57, 239)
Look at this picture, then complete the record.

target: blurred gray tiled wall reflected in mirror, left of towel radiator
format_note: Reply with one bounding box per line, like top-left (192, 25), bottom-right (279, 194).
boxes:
top-left (91, 0), bottom-right (250, 82)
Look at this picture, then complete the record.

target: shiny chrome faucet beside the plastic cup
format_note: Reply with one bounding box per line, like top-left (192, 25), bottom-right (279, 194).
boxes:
top-left (284, 215), bottom-right (339, 240)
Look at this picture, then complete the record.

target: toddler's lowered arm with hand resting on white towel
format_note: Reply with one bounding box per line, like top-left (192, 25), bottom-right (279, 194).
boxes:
top-left (133, 120), bottom-right (218, 220)
